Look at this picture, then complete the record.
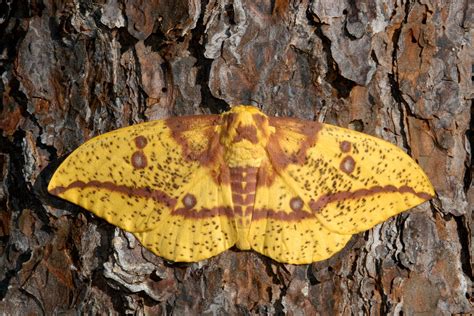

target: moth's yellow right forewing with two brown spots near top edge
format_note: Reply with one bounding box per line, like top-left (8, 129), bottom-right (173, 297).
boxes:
top-left (262, 119), bottom-right (435, 234)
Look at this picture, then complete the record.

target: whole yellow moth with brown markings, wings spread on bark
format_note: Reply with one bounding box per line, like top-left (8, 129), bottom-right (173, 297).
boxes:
top-left (48, 106), bottom-right (434, 264)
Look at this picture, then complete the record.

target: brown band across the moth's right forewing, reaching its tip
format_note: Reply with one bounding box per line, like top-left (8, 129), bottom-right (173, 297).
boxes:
top-left (309, 185), bottom-right (433, 212)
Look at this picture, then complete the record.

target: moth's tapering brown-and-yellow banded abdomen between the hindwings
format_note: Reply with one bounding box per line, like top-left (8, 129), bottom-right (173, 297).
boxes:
top-left (230, 167), bottom-right (258, 250)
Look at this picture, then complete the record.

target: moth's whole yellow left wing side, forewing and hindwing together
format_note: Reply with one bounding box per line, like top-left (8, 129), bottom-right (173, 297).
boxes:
top-left (48, 115), bottom-right (236, 261)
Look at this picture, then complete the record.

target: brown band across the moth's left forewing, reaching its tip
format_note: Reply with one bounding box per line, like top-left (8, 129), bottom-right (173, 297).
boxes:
top-left (49, 180), bottom-right (177, 208)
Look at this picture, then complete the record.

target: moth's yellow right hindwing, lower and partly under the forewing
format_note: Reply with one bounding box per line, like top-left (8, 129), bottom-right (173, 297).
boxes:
top-left (249, 170), bottom-right (351, 264)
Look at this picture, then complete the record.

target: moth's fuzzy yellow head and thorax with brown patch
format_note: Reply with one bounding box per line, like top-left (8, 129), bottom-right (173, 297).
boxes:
top-left (219, 105), bottom-right (274, 167)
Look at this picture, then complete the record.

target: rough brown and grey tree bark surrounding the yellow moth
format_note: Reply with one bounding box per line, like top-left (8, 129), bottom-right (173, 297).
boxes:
top-left (0, 0), bottom-right (474, 315)
